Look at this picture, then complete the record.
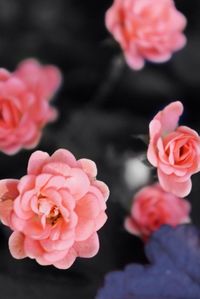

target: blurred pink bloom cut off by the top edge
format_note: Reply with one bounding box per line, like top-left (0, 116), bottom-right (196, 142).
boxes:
top-left (106, 0), bottom-right (186, 70)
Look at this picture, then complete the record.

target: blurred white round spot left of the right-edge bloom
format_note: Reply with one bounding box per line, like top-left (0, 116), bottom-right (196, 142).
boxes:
top-left (124, 157), bottom-right (150, 189)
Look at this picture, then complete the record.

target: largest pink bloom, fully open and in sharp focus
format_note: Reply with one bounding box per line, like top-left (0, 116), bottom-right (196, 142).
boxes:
top-left (0, 149), bottom-right (109, 269)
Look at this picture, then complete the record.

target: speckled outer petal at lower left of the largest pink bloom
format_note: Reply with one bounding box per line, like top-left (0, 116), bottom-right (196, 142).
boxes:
top-left (8, 231), bottom-right (26, 259)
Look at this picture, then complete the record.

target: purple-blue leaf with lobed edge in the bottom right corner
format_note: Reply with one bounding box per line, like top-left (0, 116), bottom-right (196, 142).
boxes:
top-left (96, 225), bottom-right (200, 299)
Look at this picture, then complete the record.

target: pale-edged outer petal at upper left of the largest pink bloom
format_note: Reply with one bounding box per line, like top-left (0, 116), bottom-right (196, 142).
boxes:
top-left (27, 151), bottom-right (49, 175)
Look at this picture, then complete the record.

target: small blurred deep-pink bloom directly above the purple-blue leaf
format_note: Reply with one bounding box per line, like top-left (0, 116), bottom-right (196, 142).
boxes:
top-left (125, 183), bottom-right (190, 241)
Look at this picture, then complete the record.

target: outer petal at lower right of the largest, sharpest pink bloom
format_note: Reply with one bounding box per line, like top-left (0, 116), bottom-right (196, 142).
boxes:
top-left (74, 233), bottom-right (99, 258)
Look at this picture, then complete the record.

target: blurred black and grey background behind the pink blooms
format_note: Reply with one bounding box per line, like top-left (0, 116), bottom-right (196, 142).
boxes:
top-left (0, 0), bottom-right (200, 299)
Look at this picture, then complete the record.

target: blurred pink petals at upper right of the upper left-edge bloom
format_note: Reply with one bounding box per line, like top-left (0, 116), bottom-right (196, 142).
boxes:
top-left (14, 58), bottom-right (62, 100)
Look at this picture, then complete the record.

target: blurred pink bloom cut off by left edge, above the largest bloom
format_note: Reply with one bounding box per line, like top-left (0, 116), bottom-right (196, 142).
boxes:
top-left (0, 61), bottom-right (60, 155)
